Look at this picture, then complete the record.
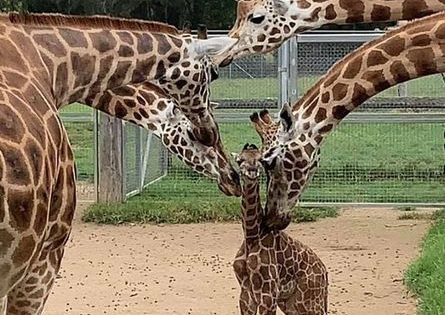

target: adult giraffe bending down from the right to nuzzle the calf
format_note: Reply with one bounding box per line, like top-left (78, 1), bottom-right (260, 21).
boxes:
top-left (251, 12), bottom-right (445, 222)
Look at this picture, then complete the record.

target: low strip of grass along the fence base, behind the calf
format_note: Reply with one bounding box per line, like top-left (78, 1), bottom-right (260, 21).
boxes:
top-left (82, 197), bottom-right (338, 225)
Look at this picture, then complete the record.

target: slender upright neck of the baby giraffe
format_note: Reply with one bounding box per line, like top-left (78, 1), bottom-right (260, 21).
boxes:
top-left (241, 178), bottom-right (263, 246)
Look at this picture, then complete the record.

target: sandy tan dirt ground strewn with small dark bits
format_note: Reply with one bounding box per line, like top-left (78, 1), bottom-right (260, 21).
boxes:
top-left (45, 205), bottom-right (429, 315)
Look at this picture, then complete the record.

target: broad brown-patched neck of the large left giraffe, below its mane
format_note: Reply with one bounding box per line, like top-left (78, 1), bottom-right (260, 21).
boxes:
top-left (25, 26), bottom-right (186, 107)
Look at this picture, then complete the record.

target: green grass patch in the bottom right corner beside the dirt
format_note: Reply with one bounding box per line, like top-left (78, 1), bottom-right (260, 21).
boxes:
top-left (405, 210), bottom-right (445, 315)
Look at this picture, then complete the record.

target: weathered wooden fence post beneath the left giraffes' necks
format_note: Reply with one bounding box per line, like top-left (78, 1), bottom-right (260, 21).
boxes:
top-left (98, 114), bottom-right (125, 203)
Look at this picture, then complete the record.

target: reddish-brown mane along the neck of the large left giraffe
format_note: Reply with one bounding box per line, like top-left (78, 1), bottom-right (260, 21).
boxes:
top-left (4, 12), bottom-right (181, 35)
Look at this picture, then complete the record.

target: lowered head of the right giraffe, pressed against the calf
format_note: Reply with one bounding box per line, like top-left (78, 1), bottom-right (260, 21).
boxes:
top-left (252, 104), bottom-right (320, 212)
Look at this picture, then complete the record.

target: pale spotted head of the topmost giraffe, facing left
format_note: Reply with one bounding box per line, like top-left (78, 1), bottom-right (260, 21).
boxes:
top-left (215, 0), bottom-right (318, 66)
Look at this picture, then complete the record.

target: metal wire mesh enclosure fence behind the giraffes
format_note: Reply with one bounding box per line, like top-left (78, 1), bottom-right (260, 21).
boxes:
top-left (63, 31), bottom-right (445, 205)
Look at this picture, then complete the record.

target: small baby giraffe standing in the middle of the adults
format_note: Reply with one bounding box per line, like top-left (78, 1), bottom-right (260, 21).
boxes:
top-left (233, 144), bottom-right (328, 315)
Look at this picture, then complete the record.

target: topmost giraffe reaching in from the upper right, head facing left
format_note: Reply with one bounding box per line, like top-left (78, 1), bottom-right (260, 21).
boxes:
top-left (214, 0), bottom-right (445, 66)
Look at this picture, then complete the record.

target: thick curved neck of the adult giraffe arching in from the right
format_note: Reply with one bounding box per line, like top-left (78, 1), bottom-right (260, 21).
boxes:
top-left (293, 12), bottom-right (445, 145)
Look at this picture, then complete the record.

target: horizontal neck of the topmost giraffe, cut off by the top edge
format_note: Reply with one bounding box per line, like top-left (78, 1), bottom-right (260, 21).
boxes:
top-left (288, 0), bottom-right (445, 33)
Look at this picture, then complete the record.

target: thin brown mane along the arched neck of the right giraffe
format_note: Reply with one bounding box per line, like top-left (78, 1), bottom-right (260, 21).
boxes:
top-left (292, 12), bottom-right (445, 111)
